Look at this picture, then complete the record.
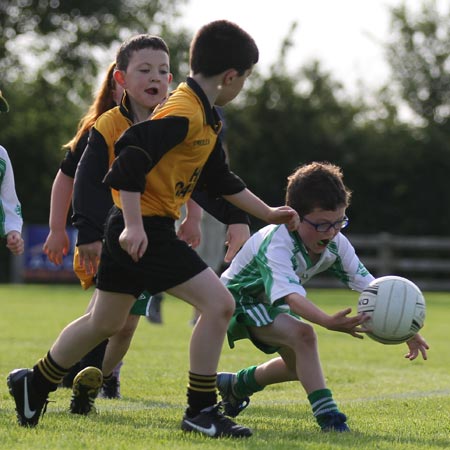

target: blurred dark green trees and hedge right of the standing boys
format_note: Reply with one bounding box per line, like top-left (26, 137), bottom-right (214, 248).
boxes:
top-left (225, 2), bottom-right (450, 235)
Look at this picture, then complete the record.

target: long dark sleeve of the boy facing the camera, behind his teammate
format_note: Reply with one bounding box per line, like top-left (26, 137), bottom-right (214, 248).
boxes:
top-left (72, 128), bottom-right (112, 245)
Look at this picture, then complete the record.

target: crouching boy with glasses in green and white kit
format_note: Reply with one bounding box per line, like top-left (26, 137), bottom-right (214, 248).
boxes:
top-left (217, 162), bottom-right (428, 432)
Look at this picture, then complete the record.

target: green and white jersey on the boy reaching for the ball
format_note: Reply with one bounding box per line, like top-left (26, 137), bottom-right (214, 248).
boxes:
top-left (221, 225), bottom-right (374, 306)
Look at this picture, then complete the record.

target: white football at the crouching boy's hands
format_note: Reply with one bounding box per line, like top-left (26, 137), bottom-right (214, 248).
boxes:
top-left (358, 275), bottom-right (425, 344)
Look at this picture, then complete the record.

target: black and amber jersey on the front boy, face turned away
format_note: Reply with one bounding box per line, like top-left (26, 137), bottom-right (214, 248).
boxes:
top-left (105, 78), bottom-right (245, 219)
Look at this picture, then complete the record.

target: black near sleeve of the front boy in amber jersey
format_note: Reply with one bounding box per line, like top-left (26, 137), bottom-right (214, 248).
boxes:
top-left (104, 117), bottom-right (189, 194)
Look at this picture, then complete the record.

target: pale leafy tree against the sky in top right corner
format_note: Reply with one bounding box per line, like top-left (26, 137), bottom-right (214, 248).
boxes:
top-left (386, 0), bottom-right (450, 125)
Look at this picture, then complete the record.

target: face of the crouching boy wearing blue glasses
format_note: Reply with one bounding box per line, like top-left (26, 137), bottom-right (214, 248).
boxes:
top-left (297, 207), bottom-right (346, 255)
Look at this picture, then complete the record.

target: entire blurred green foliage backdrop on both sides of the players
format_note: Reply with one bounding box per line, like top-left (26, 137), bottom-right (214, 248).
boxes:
top-left (0, 0), bottom-right (450, 246)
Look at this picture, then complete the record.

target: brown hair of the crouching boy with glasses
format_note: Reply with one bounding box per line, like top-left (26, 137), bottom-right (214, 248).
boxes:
top-left (286, 162), bottom-right (351, 217)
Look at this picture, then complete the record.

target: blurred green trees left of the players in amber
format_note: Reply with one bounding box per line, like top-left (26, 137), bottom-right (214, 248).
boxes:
top-left (0, 0), bottom-right (191, 279)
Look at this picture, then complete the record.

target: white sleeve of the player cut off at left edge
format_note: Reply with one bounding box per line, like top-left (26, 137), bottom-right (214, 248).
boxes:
top-left (0, 146), bottom-right (23, 237)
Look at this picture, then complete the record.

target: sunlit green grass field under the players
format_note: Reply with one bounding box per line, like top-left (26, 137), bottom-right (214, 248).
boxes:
top-left (0, 285), bottom-right (450, 450)
